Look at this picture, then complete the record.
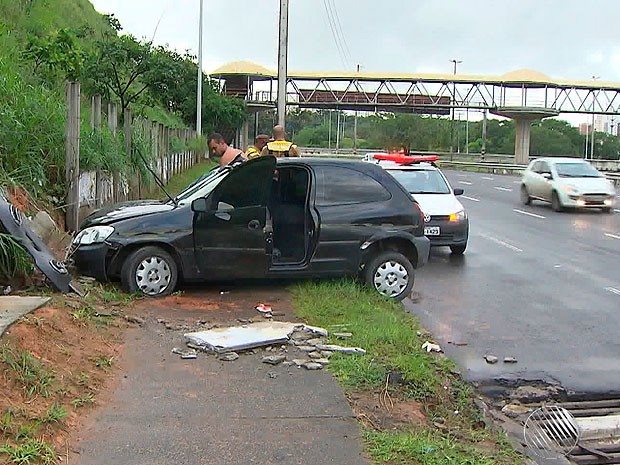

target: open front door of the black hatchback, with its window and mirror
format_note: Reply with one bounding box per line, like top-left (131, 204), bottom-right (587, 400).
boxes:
top-left (192, 156), bottom-right (276, 279)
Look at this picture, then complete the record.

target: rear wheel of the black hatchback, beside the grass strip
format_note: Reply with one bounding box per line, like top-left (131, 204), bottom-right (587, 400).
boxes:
top-left (364, 252), bottom-right (415, 300)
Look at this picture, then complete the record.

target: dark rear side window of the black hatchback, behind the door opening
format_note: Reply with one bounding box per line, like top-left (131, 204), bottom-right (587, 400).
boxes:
top-left (315, 167), bottom-right (392, 205)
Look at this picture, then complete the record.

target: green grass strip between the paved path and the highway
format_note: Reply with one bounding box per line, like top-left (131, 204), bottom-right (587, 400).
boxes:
top-left (292, 280), bottom-right (520, 465)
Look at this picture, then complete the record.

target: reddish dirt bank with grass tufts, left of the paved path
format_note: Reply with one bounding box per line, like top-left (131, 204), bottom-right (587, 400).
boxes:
top-left (0, 296), bottom-right (124, 463)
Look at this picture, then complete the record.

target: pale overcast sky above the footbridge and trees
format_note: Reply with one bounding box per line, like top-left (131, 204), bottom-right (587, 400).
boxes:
top-left (91, 0), bottom-right (620, 125)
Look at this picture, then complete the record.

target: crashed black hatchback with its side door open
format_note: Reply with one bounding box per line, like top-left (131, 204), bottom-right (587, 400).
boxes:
top-left (73, 156), bottom-right (430, 299)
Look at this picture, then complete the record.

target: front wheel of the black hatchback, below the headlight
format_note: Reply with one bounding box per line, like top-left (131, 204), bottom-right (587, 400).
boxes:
top-left (121, 246), bottom-right (178, 297)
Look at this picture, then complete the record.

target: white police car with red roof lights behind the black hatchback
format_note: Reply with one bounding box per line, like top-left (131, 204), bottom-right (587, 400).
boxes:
top-left (365, 152), bottom-right (469, 255)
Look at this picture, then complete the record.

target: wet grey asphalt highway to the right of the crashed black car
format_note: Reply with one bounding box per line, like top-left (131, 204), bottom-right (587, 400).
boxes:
top-left (406, 171), bottom-right (620, 396)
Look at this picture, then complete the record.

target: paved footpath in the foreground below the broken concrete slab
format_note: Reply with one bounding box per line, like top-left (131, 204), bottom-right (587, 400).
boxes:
top-left (70, 291), bottom-right (368, 465)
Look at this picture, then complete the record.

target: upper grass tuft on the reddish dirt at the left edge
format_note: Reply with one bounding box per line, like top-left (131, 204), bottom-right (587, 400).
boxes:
top-left (0, 345), bottom-right (54, 397)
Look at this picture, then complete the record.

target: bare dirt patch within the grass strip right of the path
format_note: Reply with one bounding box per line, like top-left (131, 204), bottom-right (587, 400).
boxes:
top-left (347, 391), bottom-right (428, 431)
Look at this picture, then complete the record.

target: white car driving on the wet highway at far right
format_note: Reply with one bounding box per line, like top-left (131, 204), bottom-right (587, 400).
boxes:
top-left (521, 157), bottom-right (616, 213)
